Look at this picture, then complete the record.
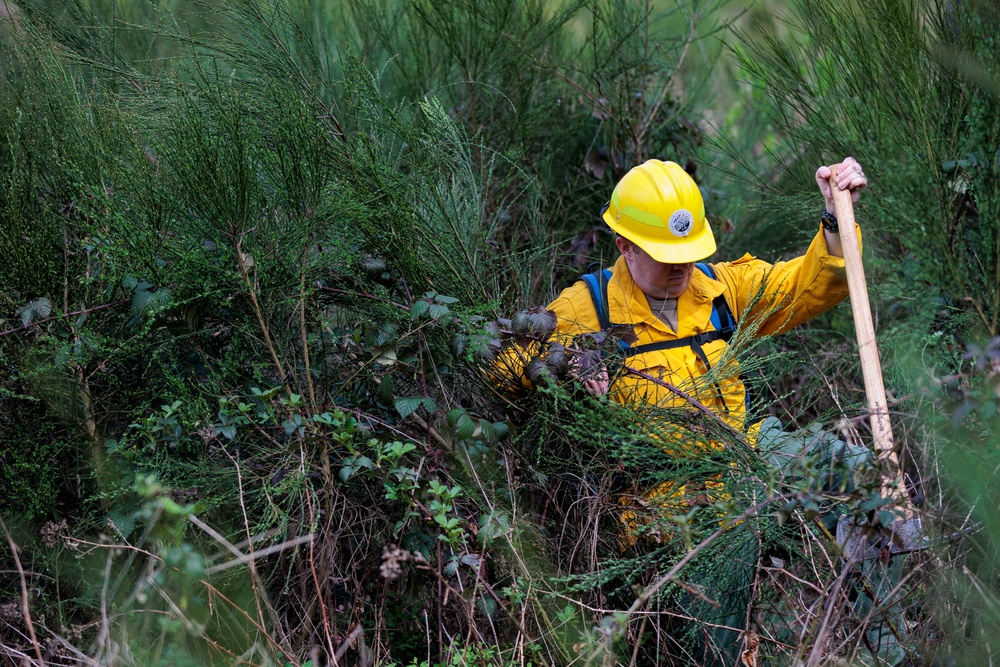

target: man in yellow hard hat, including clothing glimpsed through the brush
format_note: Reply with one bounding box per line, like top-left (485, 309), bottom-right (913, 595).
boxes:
top-left (500, 157), bottom-right (868, 665)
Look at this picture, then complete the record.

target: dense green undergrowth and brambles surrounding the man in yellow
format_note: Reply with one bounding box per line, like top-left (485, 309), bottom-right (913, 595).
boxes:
top-left (0, 0), bottom-right (1000, 667)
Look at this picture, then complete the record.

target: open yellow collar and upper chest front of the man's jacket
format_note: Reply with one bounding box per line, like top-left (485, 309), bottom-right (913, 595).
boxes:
top-left (608, 256), bottom-right (725, 337)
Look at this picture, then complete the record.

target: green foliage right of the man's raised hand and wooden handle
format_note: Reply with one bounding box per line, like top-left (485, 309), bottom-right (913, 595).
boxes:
top-left (737, 0), bottom-right (1000, 664)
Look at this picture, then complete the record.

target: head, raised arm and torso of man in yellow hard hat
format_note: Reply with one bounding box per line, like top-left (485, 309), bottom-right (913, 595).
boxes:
top-left (548, 157), bottom-right (868, 429)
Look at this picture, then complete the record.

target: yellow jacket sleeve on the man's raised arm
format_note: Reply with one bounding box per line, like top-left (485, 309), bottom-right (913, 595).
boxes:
top-left (715, 227), bottom-right (861, 336)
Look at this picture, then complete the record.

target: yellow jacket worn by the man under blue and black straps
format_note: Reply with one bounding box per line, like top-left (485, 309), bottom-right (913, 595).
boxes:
top-left (504, 228), bottom-right (848, 429)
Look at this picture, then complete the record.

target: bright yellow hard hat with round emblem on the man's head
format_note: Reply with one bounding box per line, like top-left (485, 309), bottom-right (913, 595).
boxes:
top-left (602, 160), bottom-right (715, 264)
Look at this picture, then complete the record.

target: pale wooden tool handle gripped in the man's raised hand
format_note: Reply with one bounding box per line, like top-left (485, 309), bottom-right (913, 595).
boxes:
top-left (830, 165), bottom-right (905, 496)
